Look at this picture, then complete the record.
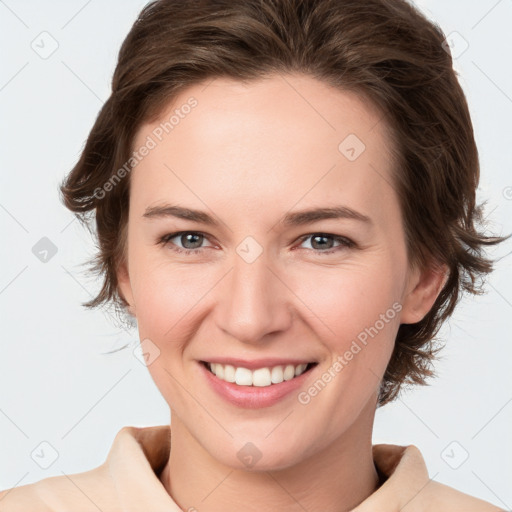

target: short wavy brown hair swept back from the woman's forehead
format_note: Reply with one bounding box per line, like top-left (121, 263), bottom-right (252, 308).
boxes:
top-left (60, 0), bottom-right (510, 405)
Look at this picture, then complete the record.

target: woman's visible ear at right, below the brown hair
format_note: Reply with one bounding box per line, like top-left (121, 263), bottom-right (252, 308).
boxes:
top-left (400, 264), bottom-right (449, 324)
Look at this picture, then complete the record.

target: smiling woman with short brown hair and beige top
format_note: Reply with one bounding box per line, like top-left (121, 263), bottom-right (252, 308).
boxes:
top-left (0, 0), bottom-right (504, 512)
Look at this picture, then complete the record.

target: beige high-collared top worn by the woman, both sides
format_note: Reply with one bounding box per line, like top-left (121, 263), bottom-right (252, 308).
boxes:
top-left (0, 425), bottom-right (503, 512)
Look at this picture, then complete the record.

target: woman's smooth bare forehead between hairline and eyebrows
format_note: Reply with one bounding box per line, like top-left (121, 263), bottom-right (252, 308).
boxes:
top-left (131, 75), bottom-right (396, 224)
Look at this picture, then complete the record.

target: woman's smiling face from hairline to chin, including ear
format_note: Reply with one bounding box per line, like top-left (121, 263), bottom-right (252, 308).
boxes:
top-left (119, 75), bottom-right (438, 468)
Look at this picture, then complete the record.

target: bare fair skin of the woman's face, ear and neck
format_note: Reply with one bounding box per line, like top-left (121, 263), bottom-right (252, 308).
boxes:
top-left (118, 74), bottom-right (443, 512)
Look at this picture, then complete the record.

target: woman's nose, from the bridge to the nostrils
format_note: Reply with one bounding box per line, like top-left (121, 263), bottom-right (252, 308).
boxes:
top-left (216, 254), bottom-right (293, 344)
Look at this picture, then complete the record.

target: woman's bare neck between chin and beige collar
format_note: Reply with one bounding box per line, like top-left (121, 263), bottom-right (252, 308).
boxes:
top-left (160, 403), bottom-right (379, 512)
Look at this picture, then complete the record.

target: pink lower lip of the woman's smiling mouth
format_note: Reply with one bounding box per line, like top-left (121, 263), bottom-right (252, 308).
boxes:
top-left (199, 363), bottom-right (314, 409)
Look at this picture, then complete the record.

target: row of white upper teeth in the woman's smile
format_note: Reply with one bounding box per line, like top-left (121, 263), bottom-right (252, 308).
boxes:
top-left (208, 363), bottom-right (308, 387)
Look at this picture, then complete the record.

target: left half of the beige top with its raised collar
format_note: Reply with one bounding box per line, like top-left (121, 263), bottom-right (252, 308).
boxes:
top-left (0, 425), bottom-right (173, 512)
